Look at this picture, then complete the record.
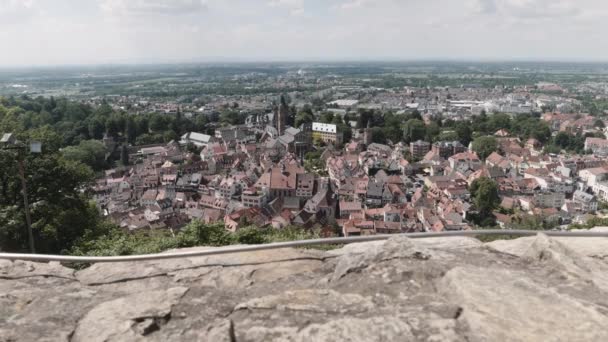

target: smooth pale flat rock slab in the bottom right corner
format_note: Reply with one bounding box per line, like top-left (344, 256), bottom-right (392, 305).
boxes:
top-left (439, 267), bottom-right (608, 341)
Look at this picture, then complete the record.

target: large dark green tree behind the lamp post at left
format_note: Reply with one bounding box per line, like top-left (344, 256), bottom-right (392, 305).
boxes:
top-left (0, 152), bottom-right (101, 253)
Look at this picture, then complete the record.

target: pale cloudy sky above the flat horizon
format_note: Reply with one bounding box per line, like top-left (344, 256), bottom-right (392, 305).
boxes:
top-left (0, 0), bottom-right (608, 67)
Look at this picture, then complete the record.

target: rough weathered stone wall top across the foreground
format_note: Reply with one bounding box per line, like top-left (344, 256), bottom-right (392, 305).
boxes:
top-left (0, 230), bottom-right (608, 342)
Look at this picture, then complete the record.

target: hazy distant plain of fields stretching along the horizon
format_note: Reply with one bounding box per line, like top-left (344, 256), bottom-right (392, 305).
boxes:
top-left (0, 62), bottom-right (608, 98)
